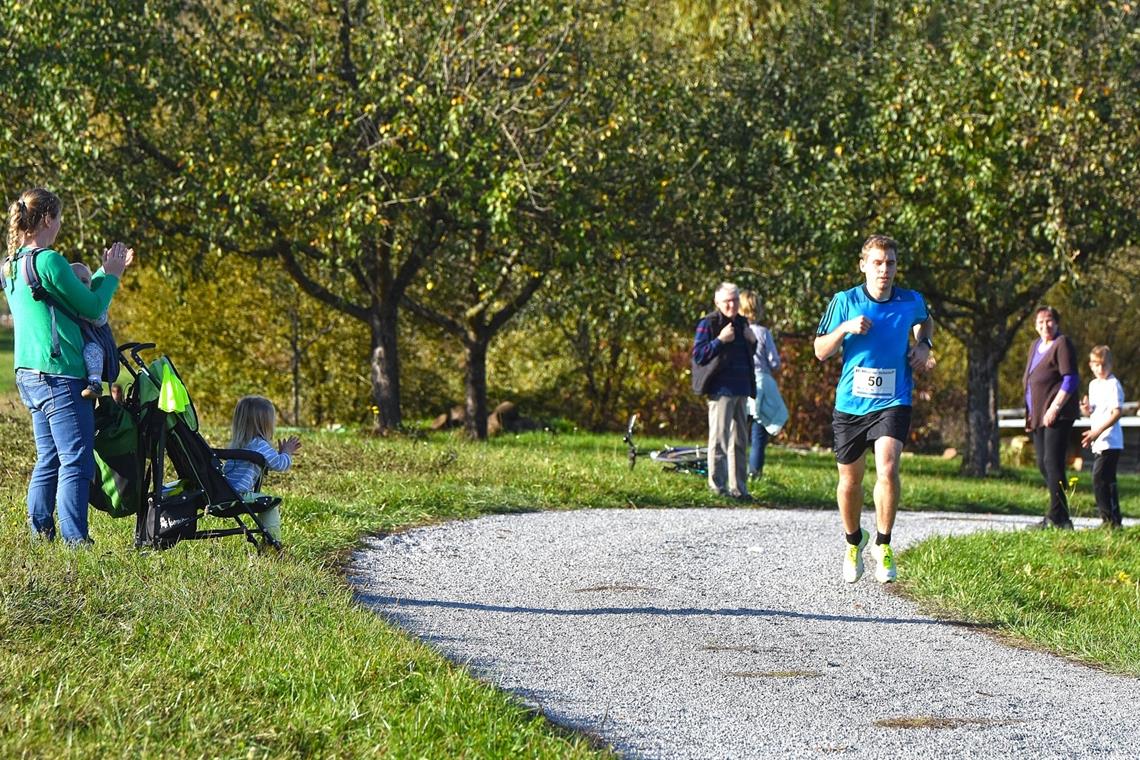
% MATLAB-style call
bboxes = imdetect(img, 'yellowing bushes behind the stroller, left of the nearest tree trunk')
[111,256,373,426]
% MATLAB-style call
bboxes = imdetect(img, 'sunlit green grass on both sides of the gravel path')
[0,394,1140,758]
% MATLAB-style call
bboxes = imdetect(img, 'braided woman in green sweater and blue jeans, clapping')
[3,188,133,545]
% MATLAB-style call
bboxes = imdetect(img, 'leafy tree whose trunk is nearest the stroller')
[4,0,620,426]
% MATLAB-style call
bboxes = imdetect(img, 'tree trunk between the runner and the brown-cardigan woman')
[962,333,1003,477]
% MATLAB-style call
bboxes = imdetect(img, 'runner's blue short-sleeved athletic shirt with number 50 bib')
[816,285,930,415]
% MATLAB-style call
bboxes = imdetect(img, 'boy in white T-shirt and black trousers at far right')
[1081,345,1124,530]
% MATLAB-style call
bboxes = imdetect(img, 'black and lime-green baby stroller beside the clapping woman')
[92,343,282,550]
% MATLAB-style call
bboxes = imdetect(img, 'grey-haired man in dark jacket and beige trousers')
[692,283,756,501]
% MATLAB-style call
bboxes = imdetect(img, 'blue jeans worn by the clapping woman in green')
[16,369,95,544]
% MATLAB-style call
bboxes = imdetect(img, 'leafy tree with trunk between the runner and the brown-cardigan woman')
[714,0,1140,474]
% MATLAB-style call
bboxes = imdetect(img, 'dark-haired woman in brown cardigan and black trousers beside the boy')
[1023,307,1081,529]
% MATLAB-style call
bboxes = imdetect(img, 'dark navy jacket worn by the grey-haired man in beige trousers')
[692,311,756,399]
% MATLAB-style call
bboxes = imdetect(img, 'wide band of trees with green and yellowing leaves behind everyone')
[0,0,1140,458]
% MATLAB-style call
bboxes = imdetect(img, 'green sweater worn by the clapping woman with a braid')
[5,248,119,378]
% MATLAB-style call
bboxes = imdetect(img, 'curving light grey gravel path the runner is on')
[350,508,1140,760]
